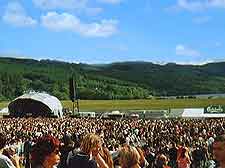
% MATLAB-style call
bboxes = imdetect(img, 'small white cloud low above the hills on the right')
[176,44,201,57]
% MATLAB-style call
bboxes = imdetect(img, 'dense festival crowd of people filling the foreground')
[0,117,225,168]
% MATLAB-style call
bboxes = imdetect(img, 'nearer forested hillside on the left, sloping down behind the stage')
[0,58,149,100]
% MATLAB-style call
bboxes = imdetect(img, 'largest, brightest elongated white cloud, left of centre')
[41,12,118,37]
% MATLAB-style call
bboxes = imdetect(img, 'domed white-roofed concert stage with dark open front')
[8,92,63,117]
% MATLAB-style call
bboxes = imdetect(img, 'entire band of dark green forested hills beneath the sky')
[0,57,225,100]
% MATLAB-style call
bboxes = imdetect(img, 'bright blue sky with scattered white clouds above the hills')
[0,0,225,64]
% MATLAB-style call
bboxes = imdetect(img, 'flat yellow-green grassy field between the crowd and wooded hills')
[0,98,225,111]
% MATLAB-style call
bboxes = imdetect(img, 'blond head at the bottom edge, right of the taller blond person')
[119,145,140,168]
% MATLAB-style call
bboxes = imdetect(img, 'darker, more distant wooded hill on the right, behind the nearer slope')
[92,62,225,95]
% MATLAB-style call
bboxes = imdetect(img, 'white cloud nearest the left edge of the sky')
[2,2,37,27]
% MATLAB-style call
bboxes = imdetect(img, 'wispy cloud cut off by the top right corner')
[171,0,225,12]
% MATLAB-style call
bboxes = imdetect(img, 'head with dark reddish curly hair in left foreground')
[31,135,60,166]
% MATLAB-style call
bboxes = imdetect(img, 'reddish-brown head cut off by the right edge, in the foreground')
[213,134,225,162]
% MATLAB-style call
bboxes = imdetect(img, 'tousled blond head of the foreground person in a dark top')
[80,133,101,155]
